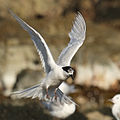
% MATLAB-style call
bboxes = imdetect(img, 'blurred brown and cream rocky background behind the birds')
[0,0,120,120]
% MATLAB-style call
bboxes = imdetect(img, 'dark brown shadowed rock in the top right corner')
[73,0,120,22]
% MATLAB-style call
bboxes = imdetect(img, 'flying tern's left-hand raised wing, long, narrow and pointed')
[9,10,55,73]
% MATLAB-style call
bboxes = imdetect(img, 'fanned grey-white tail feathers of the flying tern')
[11,84,76,105]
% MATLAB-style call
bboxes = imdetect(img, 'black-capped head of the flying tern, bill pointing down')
[62,66,75,80]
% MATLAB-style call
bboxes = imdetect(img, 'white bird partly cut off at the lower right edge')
[109,94,120,120]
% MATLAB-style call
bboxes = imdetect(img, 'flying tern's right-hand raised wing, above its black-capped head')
[57,13,86,66]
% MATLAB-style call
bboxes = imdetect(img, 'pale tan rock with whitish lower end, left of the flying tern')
[1,37,40,95]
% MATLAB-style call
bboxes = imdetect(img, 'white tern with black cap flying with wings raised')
[10,11,86,100]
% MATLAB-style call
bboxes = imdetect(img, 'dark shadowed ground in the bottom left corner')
[0,103,52,120]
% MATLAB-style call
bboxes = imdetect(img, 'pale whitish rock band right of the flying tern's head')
[75,63,120,89]
